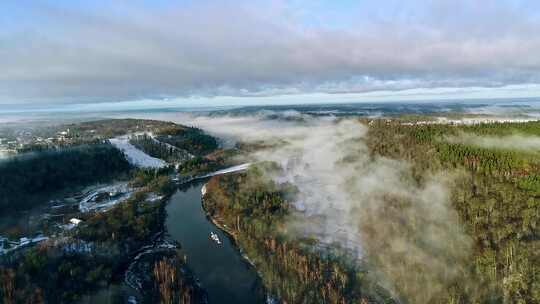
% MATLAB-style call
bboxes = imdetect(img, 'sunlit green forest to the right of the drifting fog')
[367,121,540,303]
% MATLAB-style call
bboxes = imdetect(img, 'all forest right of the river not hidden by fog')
[204,120,540,303]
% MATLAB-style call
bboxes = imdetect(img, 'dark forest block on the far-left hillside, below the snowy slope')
[0,143,131,212]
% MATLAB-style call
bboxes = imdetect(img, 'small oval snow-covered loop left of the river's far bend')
[79,183,133,212]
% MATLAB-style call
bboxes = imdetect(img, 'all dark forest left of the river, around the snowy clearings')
[0,119,216,303]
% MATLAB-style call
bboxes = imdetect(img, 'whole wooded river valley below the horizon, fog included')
[0,115,540,303]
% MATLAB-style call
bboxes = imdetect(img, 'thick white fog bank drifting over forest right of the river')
[148,111,474,303]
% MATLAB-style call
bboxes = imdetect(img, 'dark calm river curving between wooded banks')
[165,181,265,304]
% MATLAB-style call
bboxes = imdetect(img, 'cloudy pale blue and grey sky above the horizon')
[0,0,540,110]
